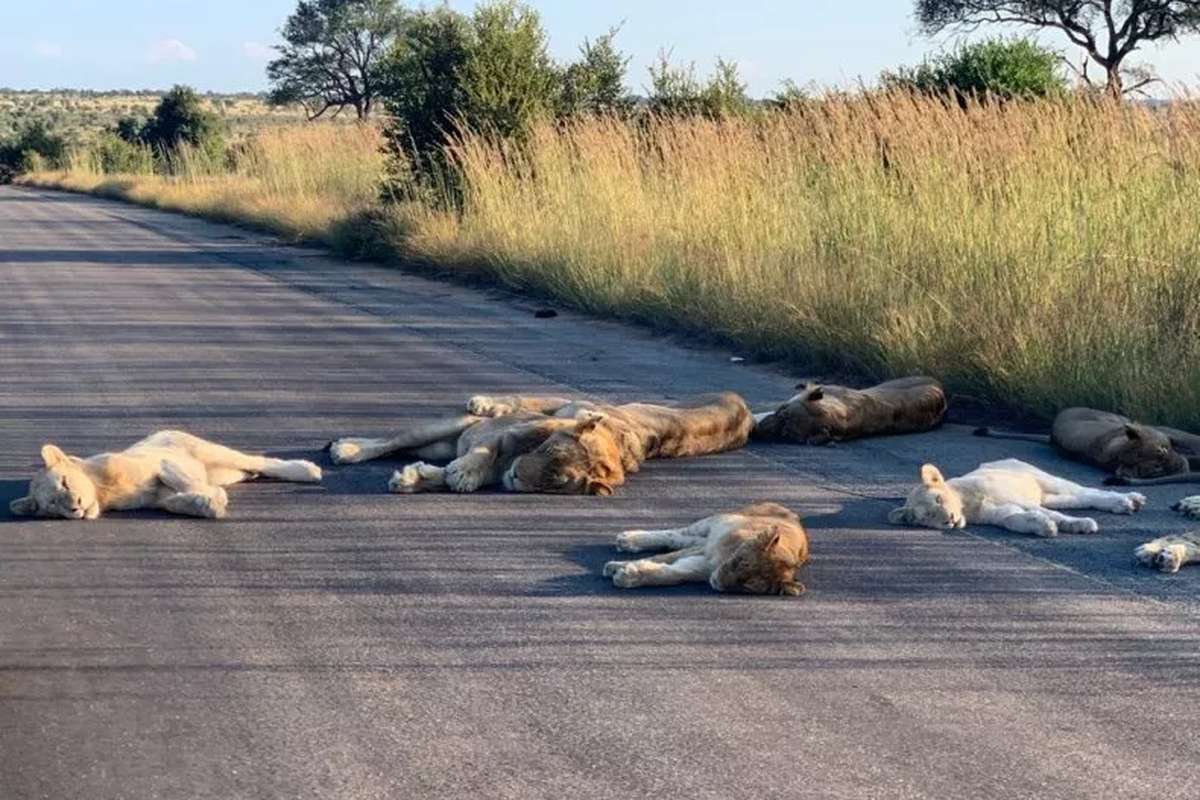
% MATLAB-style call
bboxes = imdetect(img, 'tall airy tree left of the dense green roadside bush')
[266,0,404,120]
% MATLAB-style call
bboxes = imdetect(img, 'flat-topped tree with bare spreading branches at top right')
[917,0,1200,98]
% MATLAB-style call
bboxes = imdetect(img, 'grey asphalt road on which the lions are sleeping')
[0,188,1200,800]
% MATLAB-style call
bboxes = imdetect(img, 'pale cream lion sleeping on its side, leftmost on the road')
[10,431,320,519]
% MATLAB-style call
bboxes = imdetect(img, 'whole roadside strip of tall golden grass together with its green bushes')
[14,4,1200,427]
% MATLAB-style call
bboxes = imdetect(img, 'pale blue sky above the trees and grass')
[0,0,1200,95]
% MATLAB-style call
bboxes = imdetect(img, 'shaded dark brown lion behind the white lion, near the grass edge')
[751,378,946,445]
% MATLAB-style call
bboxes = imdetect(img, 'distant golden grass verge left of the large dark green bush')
[25,125,384,241]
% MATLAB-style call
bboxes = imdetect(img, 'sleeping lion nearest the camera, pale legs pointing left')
[604,503,809,595]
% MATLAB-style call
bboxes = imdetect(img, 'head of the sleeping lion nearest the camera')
[708,523,808,595]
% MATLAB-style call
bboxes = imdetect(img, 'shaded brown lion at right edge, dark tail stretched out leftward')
[976,408,1200,486]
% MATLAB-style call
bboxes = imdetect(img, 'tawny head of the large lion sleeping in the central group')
[504,411,641,497]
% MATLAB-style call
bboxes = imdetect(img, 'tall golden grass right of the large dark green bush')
[410,96,1200,425]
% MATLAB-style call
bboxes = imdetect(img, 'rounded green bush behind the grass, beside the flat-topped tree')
[882,40,1067,101]
